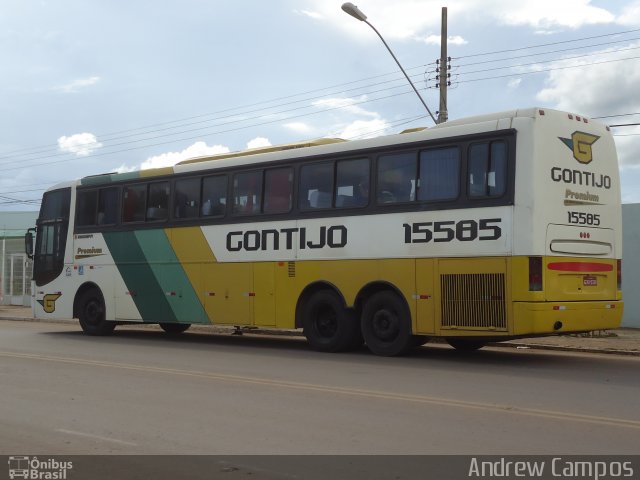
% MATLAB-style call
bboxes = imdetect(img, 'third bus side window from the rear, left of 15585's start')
[376,152,418,204]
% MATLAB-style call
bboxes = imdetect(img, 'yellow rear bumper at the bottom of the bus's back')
[513,301,624,336]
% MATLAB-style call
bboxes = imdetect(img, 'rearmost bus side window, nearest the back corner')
[467,141,507,198]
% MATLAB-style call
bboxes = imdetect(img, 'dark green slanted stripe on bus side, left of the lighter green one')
[103,230,177,322]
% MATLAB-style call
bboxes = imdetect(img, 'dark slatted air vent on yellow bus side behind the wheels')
[440,273,507,330]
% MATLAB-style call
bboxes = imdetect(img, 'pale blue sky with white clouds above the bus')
[0,0,640,211]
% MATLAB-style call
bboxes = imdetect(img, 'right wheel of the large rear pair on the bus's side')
[361,291,416,357]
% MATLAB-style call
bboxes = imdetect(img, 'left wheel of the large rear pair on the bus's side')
[302,290,360,352]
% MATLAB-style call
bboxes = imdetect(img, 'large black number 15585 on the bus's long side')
[403,218,502,243]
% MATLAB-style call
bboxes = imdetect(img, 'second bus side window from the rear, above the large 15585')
[418,147,460,201]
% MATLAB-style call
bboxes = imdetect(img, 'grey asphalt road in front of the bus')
[0,321,640,455]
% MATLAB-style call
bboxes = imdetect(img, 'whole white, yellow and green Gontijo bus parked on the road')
[27,108,623,355]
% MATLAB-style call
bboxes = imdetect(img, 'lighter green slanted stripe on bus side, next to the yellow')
[135,230,208,323]
